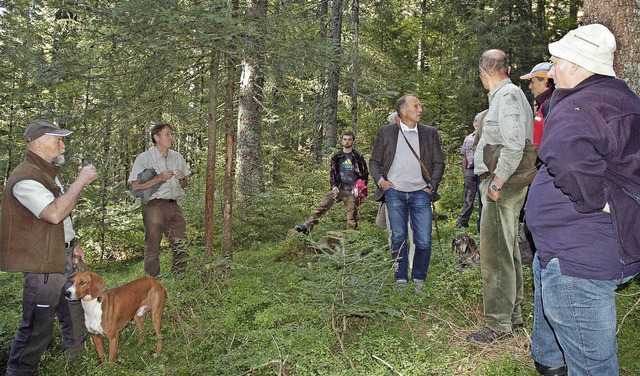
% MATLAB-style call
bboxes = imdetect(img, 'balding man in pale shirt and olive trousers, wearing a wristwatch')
[467,50,536,343]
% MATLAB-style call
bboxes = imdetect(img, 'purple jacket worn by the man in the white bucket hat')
[526,75,640,280]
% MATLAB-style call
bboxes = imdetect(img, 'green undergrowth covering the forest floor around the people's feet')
[0,203,640,375]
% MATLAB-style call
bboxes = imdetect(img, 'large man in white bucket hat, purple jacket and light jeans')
[527,24,640,375]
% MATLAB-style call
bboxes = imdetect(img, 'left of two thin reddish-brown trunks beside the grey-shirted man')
[209,52,220,256]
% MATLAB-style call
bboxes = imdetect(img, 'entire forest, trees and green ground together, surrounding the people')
[0,0,640,376]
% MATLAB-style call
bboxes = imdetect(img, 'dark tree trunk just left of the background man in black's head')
[324,0,343,154]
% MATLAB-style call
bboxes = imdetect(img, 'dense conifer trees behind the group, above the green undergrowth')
[0,0,640,258]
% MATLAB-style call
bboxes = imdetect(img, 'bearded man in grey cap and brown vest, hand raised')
[0,120,97,375]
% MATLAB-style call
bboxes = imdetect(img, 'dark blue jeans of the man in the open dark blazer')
[384,188,432,280]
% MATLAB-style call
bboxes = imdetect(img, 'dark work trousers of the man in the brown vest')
[7,247,86,375]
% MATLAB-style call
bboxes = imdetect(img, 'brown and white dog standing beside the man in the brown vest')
[66,271,167,362]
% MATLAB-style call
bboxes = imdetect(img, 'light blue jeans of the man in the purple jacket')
[531,254,632,376]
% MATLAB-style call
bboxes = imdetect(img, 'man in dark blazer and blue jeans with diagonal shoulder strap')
[369,95,444,293]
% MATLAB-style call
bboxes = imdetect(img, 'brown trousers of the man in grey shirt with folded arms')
[142,199,187,277]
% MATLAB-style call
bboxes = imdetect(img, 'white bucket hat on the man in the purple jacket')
[549,24,616,77]
